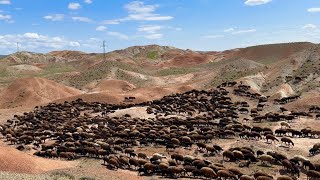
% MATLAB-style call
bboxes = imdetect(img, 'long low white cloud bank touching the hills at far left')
[0,32,81,53]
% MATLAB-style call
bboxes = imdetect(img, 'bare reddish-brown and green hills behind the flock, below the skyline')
[0,42,320,108]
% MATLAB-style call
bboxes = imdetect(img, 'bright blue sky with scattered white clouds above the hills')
[0,0,320,54]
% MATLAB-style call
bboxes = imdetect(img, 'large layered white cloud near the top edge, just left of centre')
[102,1,173,24]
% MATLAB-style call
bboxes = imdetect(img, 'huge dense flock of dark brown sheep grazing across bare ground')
[0,82,320,180]
